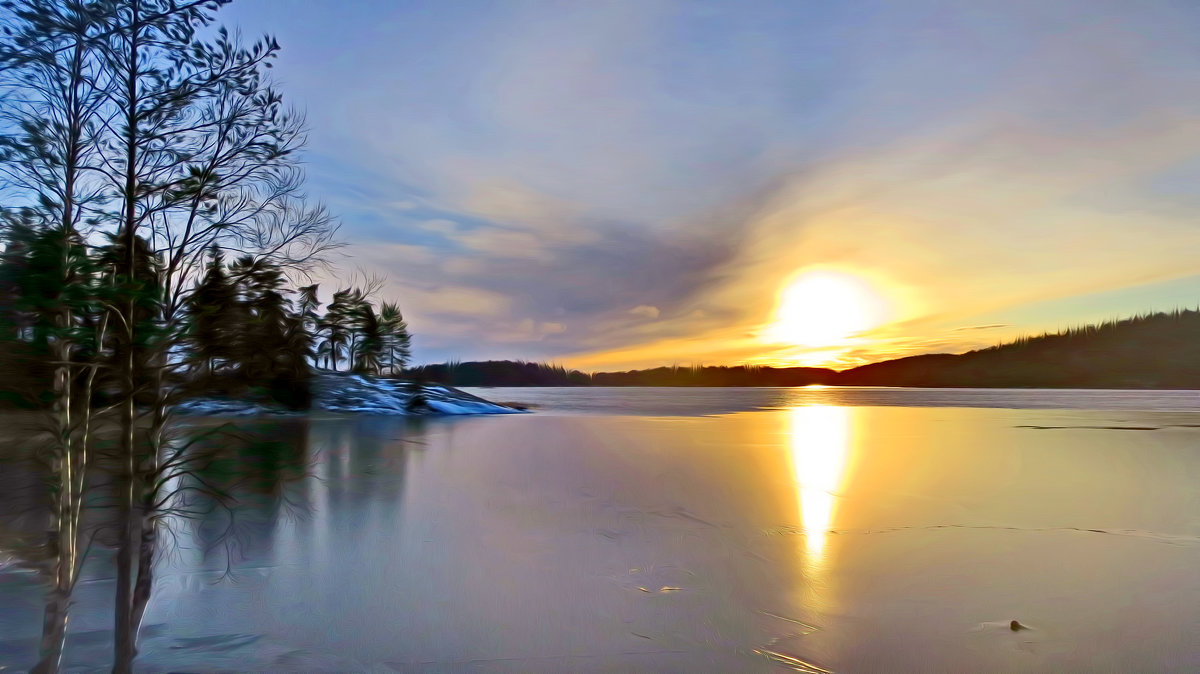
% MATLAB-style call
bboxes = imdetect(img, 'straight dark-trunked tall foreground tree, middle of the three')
[103,0,210,673]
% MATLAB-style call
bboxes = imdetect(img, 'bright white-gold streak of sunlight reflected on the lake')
[790,405,851,565]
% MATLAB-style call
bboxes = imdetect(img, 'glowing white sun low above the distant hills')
[766,271,883,348]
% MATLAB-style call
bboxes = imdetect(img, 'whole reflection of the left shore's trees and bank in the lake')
[0,417,426,666]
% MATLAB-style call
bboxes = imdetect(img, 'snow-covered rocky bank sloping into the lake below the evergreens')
[175,372,526,416]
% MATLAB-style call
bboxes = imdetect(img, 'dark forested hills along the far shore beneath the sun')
[409,311,1200,389]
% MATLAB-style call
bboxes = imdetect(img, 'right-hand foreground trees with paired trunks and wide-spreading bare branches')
[91,0,334,670]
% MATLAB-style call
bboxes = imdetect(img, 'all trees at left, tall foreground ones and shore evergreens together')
[0,0,408,672]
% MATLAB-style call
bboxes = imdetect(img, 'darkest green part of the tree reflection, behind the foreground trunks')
[0,420,310,672]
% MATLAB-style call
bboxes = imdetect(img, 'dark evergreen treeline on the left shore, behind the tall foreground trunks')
[0,233,410,409]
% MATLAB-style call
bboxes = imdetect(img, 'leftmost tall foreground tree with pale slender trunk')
[0,0,109,672]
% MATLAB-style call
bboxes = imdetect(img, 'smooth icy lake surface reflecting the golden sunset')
[0,389,1200,672]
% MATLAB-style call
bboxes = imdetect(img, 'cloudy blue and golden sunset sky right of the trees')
[220,0,1200,371]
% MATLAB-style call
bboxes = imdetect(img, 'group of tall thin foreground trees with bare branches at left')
[0,0,336,672]
